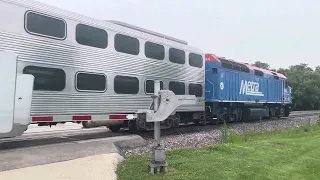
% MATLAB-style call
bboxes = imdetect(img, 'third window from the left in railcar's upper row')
[114,34,140,55]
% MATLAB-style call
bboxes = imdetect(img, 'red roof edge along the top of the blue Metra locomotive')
[206,54,287,79]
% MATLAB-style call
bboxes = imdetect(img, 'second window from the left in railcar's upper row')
[76,24,108,49]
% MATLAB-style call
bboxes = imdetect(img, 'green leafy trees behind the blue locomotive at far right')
[252,61,320,111]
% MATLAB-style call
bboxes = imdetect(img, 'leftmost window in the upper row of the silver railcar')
[25,11,67,39]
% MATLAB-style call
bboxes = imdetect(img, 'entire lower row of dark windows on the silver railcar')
[23,66,202,97]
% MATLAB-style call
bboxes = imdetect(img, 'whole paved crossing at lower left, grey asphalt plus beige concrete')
[0,131,146,180]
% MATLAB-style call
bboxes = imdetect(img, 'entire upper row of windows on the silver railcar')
[25,11,203,68]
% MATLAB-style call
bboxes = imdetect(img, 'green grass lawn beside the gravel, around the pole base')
[117,120,320,180]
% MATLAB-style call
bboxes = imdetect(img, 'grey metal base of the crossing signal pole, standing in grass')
[149,146,168,174]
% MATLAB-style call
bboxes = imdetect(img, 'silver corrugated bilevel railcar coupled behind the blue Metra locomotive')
[0,0,205,131]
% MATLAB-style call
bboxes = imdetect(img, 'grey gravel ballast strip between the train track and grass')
[121,116,319,156]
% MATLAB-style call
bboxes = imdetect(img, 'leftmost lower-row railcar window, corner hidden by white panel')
[23,66,66,91]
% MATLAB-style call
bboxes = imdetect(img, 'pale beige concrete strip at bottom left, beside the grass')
[0,153,123,180]
